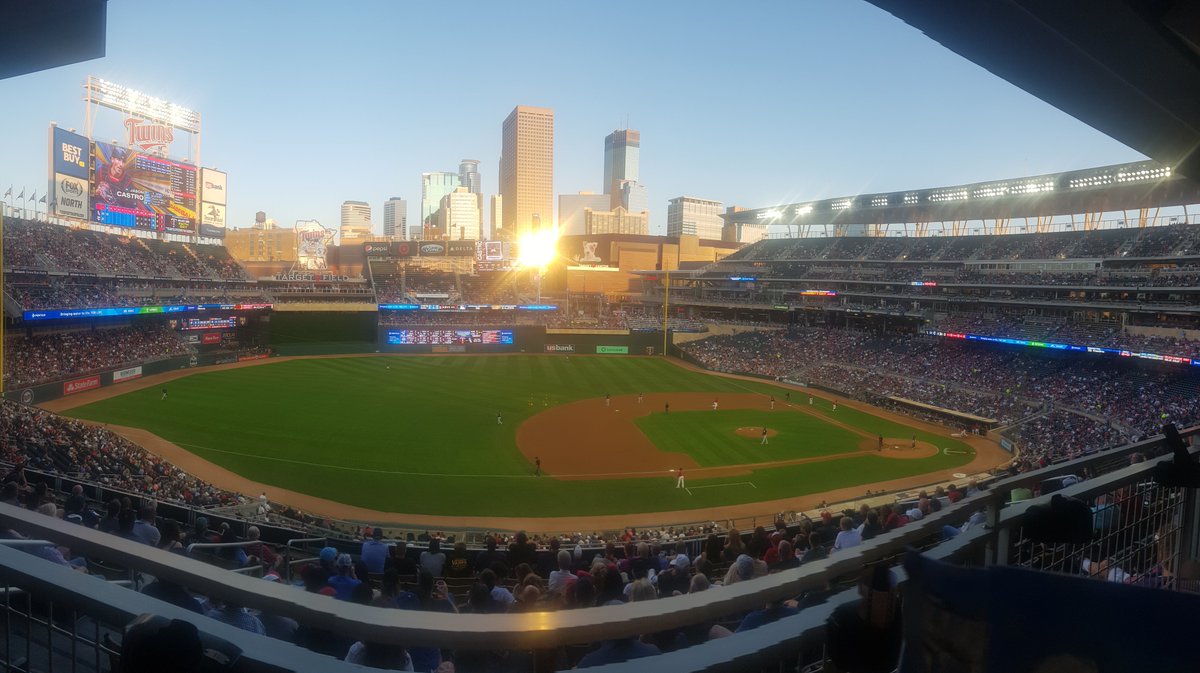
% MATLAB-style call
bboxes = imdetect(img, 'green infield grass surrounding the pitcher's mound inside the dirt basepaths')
[634,405,863,467]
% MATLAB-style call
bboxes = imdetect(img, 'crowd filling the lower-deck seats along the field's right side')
[683,328,1200,456]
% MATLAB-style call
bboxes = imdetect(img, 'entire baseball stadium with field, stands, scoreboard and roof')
[0,0,1200,673]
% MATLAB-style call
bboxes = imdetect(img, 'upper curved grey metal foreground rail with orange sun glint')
[0,428,1196,649]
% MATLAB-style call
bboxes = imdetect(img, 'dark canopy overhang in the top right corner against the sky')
[869,0,1200,180]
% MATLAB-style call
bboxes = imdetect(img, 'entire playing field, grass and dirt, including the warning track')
[48,355,1008,524]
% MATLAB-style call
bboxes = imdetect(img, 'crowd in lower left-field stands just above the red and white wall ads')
[4,325,191,390]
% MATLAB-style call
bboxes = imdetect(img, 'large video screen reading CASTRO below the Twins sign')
[91,143,197,234]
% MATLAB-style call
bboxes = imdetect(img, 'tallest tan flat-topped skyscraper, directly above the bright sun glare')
[500,106,554,238]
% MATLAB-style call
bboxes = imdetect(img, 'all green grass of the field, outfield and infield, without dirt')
[68,355,972,516]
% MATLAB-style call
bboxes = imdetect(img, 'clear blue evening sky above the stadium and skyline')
[0,0,1145,233]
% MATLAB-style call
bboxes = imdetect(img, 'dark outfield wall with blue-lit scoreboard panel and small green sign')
[377,325,662,355]
